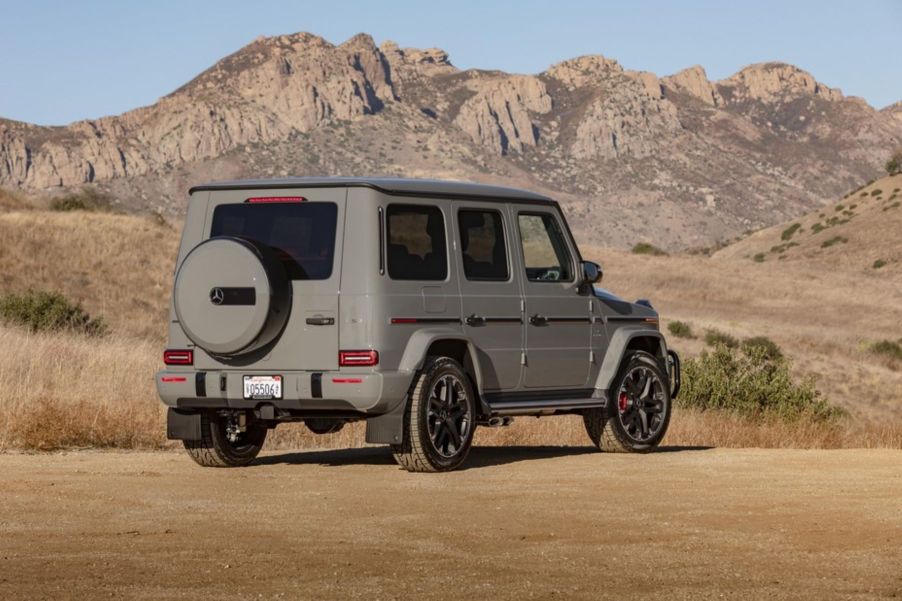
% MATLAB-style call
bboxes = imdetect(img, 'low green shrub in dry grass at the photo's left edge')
[0,290,108,336]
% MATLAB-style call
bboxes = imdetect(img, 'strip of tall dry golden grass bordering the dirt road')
[0,327,902,450]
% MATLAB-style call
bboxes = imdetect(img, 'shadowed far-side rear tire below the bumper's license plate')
[182,412,266,467]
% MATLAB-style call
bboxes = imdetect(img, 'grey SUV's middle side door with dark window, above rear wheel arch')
[454,202,524,392]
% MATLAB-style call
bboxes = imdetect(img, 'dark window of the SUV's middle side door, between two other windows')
[457,209,509,282]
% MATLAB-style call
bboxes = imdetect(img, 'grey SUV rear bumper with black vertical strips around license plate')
[154,370,413,415]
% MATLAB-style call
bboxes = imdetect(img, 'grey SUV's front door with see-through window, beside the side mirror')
[513,205,591,389]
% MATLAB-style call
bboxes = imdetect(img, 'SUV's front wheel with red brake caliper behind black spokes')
[583,351,672,453]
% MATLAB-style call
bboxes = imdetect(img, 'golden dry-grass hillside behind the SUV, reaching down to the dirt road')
[0,190,902,448]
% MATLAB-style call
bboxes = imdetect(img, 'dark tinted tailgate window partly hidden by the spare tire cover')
[210,202,338,280]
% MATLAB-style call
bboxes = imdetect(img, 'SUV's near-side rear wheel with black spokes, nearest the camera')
[392,357,476,472]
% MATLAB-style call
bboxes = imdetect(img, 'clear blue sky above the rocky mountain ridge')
[0,0,902,124]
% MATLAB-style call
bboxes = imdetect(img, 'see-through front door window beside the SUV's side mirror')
[518,213,573,282]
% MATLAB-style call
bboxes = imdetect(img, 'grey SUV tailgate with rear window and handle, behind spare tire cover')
[195,188,347,371]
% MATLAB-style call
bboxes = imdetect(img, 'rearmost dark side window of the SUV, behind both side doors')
[386,205,448,280]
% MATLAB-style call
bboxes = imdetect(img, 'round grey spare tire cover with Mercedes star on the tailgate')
[173,236,291,356]
